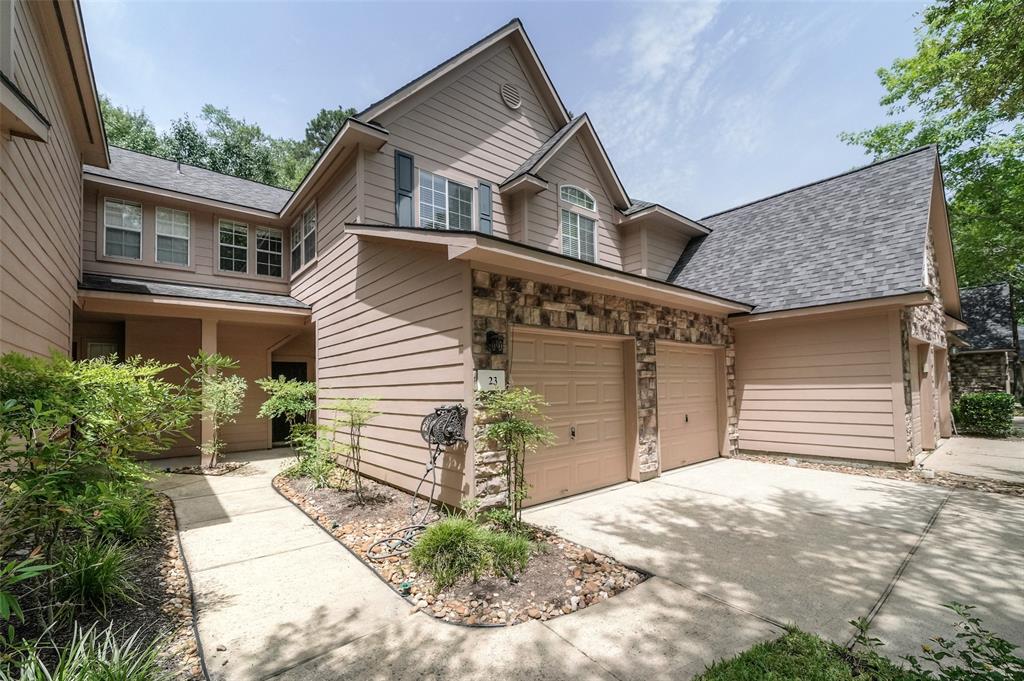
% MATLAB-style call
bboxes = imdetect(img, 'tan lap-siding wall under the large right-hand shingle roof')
[736,314,904,461]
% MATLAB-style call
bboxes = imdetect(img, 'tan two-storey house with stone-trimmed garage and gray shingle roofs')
[2,10,962,503]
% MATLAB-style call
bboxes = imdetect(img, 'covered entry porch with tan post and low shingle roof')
[72,274,316,459]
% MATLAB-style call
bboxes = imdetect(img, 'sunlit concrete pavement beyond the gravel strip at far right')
[922,437,1024,484]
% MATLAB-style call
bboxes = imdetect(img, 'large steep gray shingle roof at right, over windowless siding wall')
[669,146,936,313]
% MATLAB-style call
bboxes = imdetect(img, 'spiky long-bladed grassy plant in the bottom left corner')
[0,625,172,681]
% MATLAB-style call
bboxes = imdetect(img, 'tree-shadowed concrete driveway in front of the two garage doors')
[527,459,1024,656]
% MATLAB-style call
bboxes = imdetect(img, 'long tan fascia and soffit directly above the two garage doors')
[345,224,751,314]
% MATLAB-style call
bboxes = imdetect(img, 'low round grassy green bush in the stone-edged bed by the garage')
[410,517,531,589]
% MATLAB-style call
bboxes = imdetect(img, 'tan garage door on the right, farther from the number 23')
[657,341,719,470]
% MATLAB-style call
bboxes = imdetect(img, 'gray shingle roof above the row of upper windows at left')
[84,146,292,213]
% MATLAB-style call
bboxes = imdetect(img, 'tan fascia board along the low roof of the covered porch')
[78,289,312,324]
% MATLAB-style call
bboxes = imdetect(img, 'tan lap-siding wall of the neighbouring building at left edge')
[0,2,82,354]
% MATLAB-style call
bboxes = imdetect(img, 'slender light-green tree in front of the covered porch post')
[188,350,246,468]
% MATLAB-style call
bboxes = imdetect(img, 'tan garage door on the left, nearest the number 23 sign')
[511,329,627,505]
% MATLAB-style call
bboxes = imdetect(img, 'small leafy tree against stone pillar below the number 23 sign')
[477,388,555,521]
